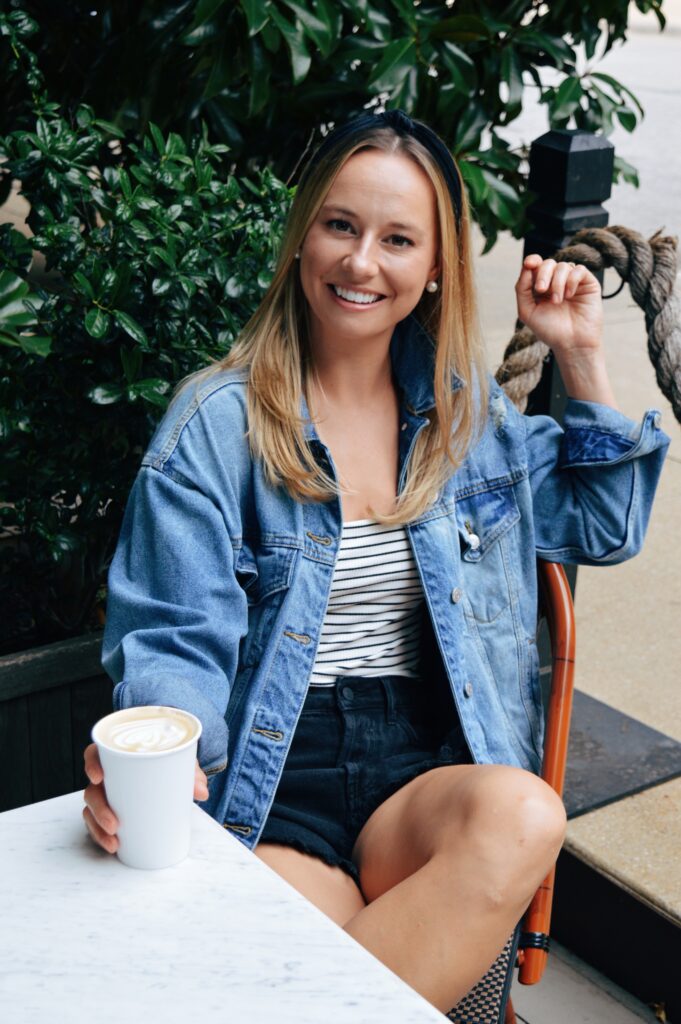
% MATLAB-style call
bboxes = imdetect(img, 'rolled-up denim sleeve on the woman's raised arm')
[524,398,670,565]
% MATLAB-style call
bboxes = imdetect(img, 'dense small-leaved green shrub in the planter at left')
[0,12,292,651]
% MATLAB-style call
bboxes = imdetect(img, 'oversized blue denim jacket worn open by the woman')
[102,317,669,849]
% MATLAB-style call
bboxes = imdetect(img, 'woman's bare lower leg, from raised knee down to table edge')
[344,768,565,1013]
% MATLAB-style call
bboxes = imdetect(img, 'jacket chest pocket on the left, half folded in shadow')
[236,544,296,668]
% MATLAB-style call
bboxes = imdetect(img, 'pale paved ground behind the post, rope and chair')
[477,6,681,1024]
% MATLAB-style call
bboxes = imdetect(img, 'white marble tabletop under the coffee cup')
[0,792,444,1024]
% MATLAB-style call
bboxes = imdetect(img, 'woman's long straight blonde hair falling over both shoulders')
[187,127,486,523]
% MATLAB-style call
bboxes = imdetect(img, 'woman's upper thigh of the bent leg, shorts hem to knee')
[351,764,565,902]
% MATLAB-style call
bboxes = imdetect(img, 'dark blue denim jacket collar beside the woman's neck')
[300,313,466,440]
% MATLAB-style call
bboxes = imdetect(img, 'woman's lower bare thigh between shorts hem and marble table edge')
[253,843,367,927]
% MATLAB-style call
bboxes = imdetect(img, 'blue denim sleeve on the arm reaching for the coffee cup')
[102,466,247,774]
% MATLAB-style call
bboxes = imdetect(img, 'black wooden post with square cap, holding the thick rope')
[523,128,614,688]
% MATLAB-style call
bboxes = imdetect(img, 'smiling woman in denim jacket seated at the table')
[84,112,668,1012]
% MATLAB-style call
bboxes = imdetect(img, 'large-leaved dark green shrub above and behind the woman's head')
[0,0,665,248]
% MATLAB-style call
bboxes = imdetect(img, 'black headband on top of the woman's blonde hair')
[301,111,462,229]
